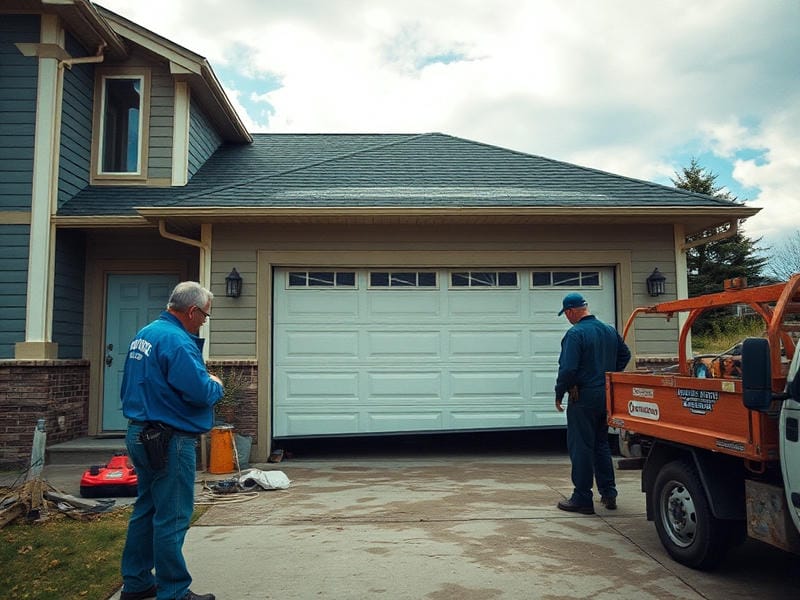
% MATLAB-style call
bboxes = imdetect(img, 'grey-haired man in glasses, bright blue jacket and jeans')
[120,281,223,600]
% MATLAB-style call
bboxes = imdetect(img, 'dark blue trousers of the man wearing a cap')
[567,388,617,506]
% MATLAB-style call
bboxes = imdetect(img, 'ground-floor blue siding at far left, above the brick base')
[0,225,30,358]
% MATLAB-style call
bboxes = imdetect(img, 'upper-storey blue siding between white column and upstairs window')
[58,35,94,208]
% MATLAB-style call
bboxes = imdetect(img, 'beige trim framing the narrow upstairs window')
[91,67,151,184]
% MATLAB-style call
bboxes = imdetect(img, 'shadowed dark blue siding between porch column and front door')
[53,229,86,358]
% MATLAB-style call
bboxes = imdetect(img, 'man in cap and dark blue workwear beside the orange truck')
[556,293,631,515]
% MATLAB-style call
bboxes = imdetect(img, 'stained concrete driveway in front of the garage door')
[170,450,800,600]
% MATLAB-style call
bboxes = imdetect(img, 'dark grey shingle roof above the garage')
[58,133,741,216]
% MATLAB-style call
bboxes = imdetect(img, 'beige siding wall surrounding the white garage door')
[210,224,677,358]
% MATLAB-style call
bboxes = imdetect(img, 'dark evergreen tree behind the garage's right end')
[672,158,768,333]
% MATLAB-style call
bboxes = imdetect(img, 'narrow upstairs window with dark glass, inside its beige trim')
[100,77,144,174]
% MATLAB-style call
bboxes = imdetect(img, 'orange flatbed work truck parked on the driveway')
[606,274,800,569]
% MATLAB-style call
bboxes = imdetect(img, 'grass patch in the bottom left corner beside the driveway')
[0,507,131,600]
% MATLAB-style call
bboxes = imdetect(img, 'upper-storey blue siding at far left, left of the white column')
[0,15,39,211]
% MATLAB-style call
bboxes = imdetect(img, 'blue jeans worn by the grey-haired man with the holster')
[122,423,197,599]
